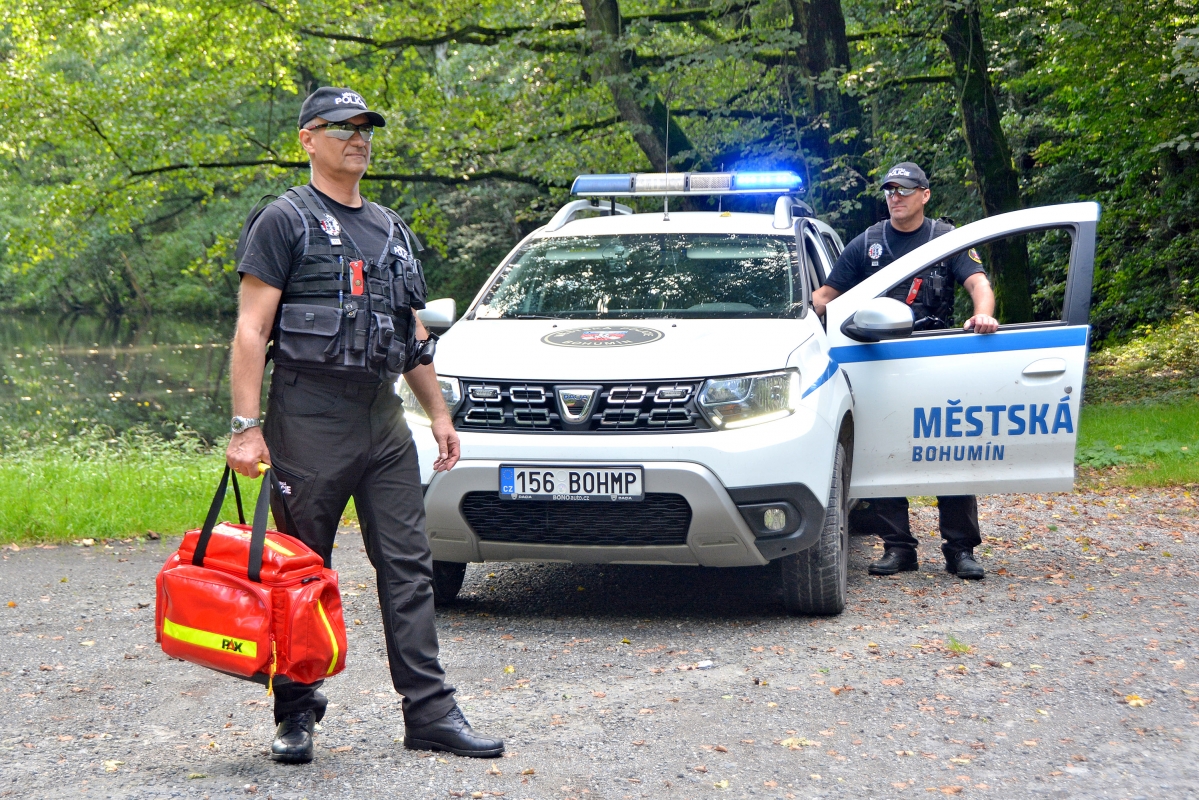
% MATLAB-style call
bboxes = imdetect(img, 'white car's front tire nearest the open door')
[778,443,849,615]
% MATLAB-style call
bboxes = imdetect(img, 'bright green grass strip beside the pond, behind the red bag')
[0,428,354,543]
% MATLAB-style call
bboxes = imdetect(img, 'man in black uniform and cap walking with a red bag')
[227,88,504,763]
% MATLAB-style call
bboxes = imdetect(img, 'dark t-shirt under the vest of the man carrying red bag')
[237,187,391,289]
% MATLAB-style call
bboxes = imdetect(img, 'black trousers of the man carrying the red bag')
[263,366,454,726]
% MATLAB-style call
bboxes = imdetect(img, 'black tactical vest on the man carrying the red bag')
[270,186,427,380]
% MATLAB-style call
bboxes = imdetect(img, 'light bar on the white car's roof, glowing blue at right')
[571,172,803,197]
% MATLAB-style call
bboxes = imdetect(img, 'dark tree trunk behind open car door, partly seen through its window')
[941,0,1032,323]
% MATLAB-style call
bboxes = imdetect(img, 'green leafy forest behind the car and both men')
[0,0,1199,341]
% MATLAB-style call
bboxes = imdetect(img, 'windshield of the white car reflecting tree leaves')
[476,234,802,319]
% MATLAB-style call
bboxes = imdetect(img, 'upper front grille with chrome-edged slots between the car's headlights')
[454,378,711,433]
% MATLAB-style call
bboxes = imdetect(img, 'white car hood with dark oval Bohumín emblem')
[435,314,819,380]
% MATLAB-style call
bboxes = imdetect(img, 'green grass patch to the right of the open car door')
[1076,399,1199,486]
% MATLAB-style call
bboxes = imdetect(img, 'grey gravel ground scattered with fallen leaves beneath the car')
[0,489,1199,800]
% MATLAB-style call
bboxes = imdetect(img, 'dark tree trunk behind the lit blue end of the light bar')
[789,0,885,237]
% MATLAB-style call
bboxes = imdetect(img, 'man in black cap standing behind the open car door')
[812,162,999,579]
